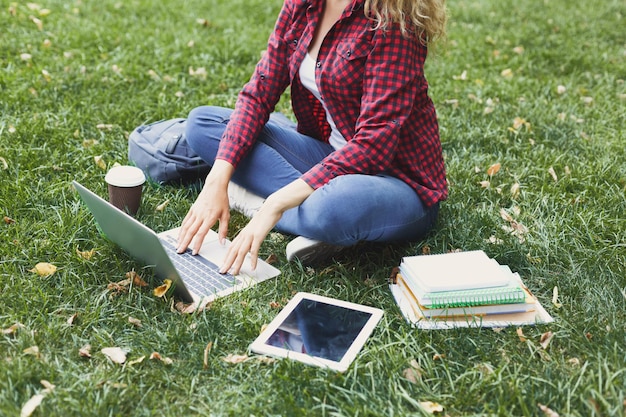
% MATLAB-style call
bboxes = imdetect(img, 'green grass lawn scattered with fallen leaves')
[0,0,626,416]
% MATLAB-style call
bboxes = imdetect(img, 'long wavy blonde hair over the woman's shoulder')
[365,0,448,45]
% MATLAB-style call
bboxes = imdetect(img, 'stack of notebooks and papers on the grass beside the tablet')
[390,251,552,328]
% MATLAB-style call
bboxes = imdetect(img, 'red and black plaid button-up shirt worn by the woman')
[217,0,447,206]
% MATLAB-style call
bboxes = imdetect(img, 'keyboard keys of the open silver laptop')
[161,236,237,296]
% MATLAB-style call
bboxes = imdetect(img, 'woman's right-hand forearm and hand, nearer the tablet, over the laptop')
[220,179,313,275]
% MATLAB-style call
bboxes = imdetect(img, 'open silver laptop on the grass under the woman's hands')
[72,181,280,308]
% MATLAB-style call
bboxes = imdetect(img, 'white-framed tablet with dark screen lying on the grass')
[250,292,383,372]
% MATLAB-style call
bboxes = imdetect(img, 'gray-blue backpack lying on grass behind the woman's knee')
[128,119,211,184]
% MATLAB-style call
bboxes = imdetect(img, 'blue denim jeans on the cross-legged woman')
[186,106,439,246]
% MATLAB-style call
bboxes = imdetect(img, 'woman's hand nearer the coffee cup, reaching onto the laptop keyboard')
[176,160,234,255]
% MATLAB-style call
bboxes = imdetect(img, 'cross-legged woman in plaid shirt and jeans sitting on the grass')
[178,0,447,274]
